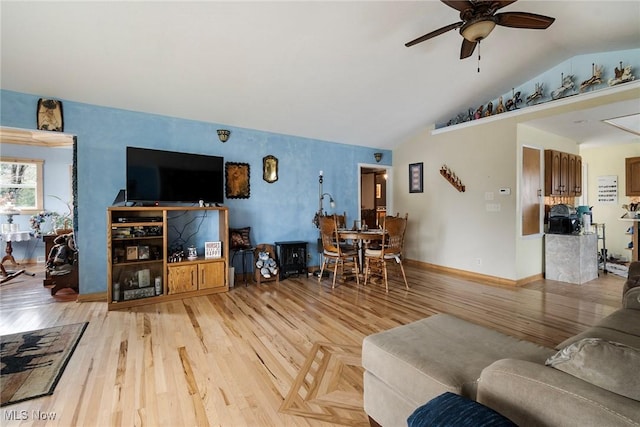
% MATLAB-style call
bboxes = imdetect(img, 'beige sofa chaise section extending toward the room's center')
[362,314,554,408]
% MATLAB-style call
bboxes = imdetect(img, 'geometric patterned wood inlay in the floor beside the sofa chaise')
[280,342,369,426]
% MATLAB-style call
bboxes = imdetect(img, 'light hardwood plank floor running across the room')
[0,266,624,426]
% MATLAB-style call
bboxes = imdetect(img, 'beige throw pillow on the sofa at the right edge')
[546,338,640,400]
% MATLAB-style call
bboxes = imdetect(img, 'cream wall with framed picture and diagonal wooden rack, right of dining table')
[393,122,517,278]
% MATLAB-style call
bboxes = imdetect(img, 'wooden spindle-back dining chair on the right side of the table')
[364,215,409,292]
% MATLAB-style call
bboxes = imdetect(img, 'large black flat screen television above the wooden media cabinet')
[126,147,224,204]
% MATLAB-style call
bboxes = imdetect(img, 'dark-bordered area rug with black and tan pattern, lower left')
[0,322,88,406]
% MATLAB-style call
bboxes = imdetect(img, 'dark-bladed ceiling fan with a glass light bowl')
[405,0,555,59]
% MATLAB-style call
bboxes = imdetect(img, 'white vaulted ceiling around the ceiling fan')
[0,0,640,148]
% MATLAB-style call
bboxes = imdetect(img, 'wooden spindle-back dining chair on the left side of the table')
[318,215,360,288]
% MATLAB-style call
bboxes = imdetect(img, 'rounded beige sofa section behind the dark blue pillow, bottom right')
[476,359,640,427]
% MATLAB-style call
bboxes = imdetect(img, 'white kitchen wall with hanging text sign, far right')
[580,143,640,259]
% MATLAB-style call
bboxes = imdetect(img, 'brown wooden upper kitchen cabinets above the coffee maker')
[544,150,582,197]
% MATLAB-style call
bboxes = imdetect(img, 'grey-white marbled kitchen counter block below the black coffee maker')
[544,233,598,285]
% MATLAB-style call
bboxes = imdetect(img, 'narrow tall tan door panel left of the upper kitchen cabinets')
[521,147,542,236]
